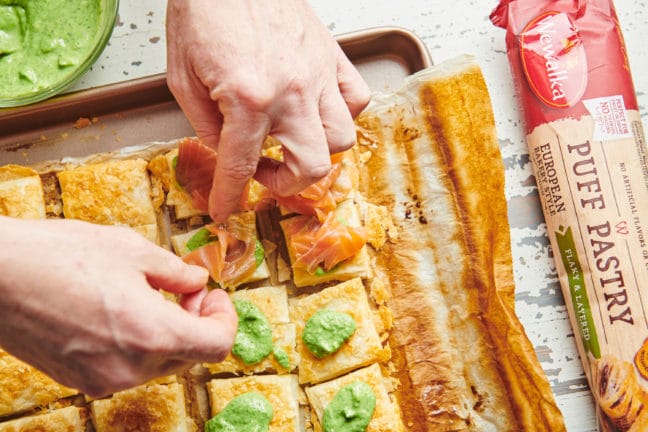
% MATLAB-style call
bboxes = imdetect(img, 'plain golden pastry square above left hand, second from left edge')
[57,159,158,243]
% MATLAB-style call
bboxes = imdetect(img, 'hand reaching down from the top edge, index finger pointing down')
[167,0,370,222]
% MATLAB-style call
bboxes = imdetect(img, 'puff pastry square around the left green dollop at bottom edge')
[207,375,302,432]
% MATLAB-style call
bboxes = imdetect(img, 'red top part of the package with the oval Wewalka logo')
[490,0,637,132]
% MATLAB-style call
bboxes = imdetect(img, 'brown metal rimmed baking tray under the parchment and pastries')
[0,27,432,165]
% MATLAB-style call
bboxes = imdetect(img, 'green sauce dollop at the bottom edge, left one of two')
[205,392,274,432]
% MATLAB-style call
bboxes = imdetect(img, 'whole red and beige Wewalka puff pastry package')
[490,0,648,432]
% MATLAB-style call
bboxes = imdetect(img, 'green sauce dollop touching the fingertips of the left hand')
[232,300,272,365]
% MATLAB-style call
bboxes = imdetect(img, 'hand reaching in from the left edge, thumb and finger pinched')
[0,217,237,396]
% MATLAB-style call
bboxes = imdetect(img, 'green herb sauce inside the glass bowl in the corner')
[0,0,101,98]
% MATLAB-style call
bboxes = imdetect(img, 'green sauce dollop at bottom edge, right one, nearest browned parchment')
[322,381,376,432]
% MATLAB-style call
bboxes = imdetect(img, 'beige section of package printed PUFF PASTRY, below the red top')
[527,112,648,374]
